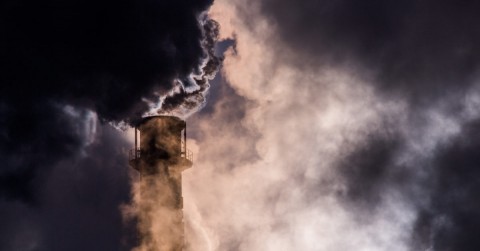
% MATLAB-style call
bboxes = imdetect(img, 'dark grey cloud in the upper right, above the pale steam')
[256,0,480,98]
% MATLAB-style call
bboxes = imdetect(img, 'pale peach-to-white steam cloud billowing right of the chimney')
[178,0,480,251]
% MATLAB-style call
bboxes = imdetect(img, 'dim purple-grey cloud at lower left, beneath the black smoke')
[0,126,135,251]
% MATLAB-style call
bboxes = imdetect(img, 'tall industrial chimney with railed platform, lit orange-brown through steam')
[129,116,192,251]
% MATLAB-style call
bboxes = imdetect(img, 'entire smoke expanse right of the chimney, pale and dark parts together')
[179,0,480,251]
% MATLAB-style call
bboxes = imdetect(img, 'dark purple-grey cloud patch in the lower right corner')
[414,120,480,250]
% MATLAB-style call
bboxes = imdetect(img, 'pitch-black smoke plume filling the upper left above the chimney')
[0,0,218,200]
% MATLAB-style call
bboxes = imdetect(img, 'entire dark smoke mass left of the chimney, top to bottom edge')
[0,0,220,250]
